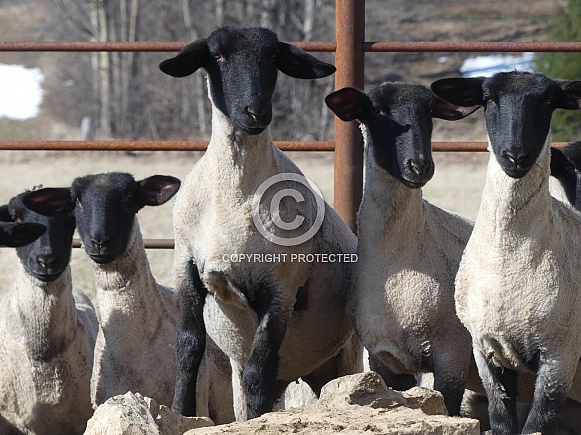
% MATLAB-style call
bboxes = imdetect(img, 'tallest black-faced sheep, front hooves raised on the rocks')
[160,28,362,420]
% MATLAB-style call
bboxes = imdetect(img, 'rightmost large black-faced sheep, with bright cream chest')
[432,72,581,433]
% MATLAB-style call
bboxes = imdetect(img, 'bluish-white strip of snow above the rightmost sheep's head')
[460,53,534,77]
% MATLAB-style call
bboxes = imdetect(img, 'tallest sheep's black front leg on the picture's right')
[242,289,290,419]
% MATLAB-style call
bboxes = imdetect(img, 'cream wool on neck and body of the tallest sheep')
[173,100,362,419]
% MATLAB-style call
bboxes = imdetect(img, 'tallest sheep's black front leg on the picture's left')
[172,260,208,417]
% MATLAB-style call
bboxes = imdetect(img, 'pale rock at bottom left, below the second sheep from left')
[85,392,214,435]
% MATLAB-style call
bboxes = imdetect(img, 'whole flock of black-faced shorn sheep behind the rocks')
[0,27,581,435]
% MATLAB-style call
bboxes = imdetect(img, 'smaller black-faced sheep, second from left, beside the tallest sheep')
[70,172,234,424]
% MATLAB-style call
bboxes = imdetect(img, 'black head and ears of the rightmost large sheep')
[432,71,581,178]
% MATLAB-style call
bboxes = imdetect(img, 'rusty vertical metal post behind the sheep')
[334,0,365,232]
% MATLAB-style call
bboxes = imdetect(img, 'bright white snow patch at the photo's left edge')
[0,64,44,121]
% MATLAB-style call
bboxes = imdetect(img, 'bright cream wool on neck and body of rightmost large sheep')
[456,135,581,401]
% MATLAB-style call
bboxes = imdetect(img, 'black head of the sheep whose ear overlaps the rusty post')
[325,82,478,189]
